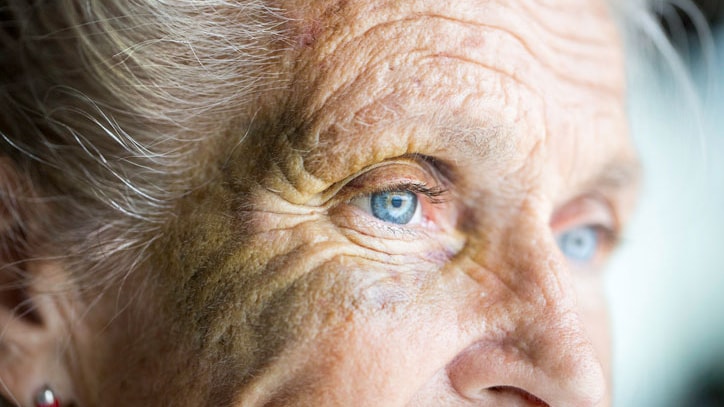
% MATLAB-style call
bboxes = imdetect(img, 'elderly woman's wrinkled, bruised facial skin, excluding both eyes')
[76,0,635,407]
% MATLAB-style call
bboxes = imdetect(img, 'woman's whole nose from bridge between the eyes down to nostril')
[447,225,607,407]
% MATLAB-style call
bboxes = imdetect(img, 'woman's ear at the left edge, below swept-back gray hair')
[0,157,74,406]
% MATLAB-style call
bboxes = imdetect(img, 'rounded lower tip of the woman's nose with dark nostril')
[448,310,606,407]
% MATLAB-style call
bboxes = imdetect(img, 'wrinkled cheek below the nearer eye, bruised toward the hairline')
[219,201,470,405]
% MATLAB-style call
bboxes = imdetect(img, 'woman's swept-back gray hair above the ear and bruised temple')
[0,0,284,283]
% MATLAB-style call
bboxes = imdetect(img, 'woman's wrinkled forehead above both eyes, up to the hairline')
[272,0,630,199]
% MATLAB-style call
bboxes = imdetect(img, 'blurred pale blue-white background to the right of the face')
[607,0,724,407]
